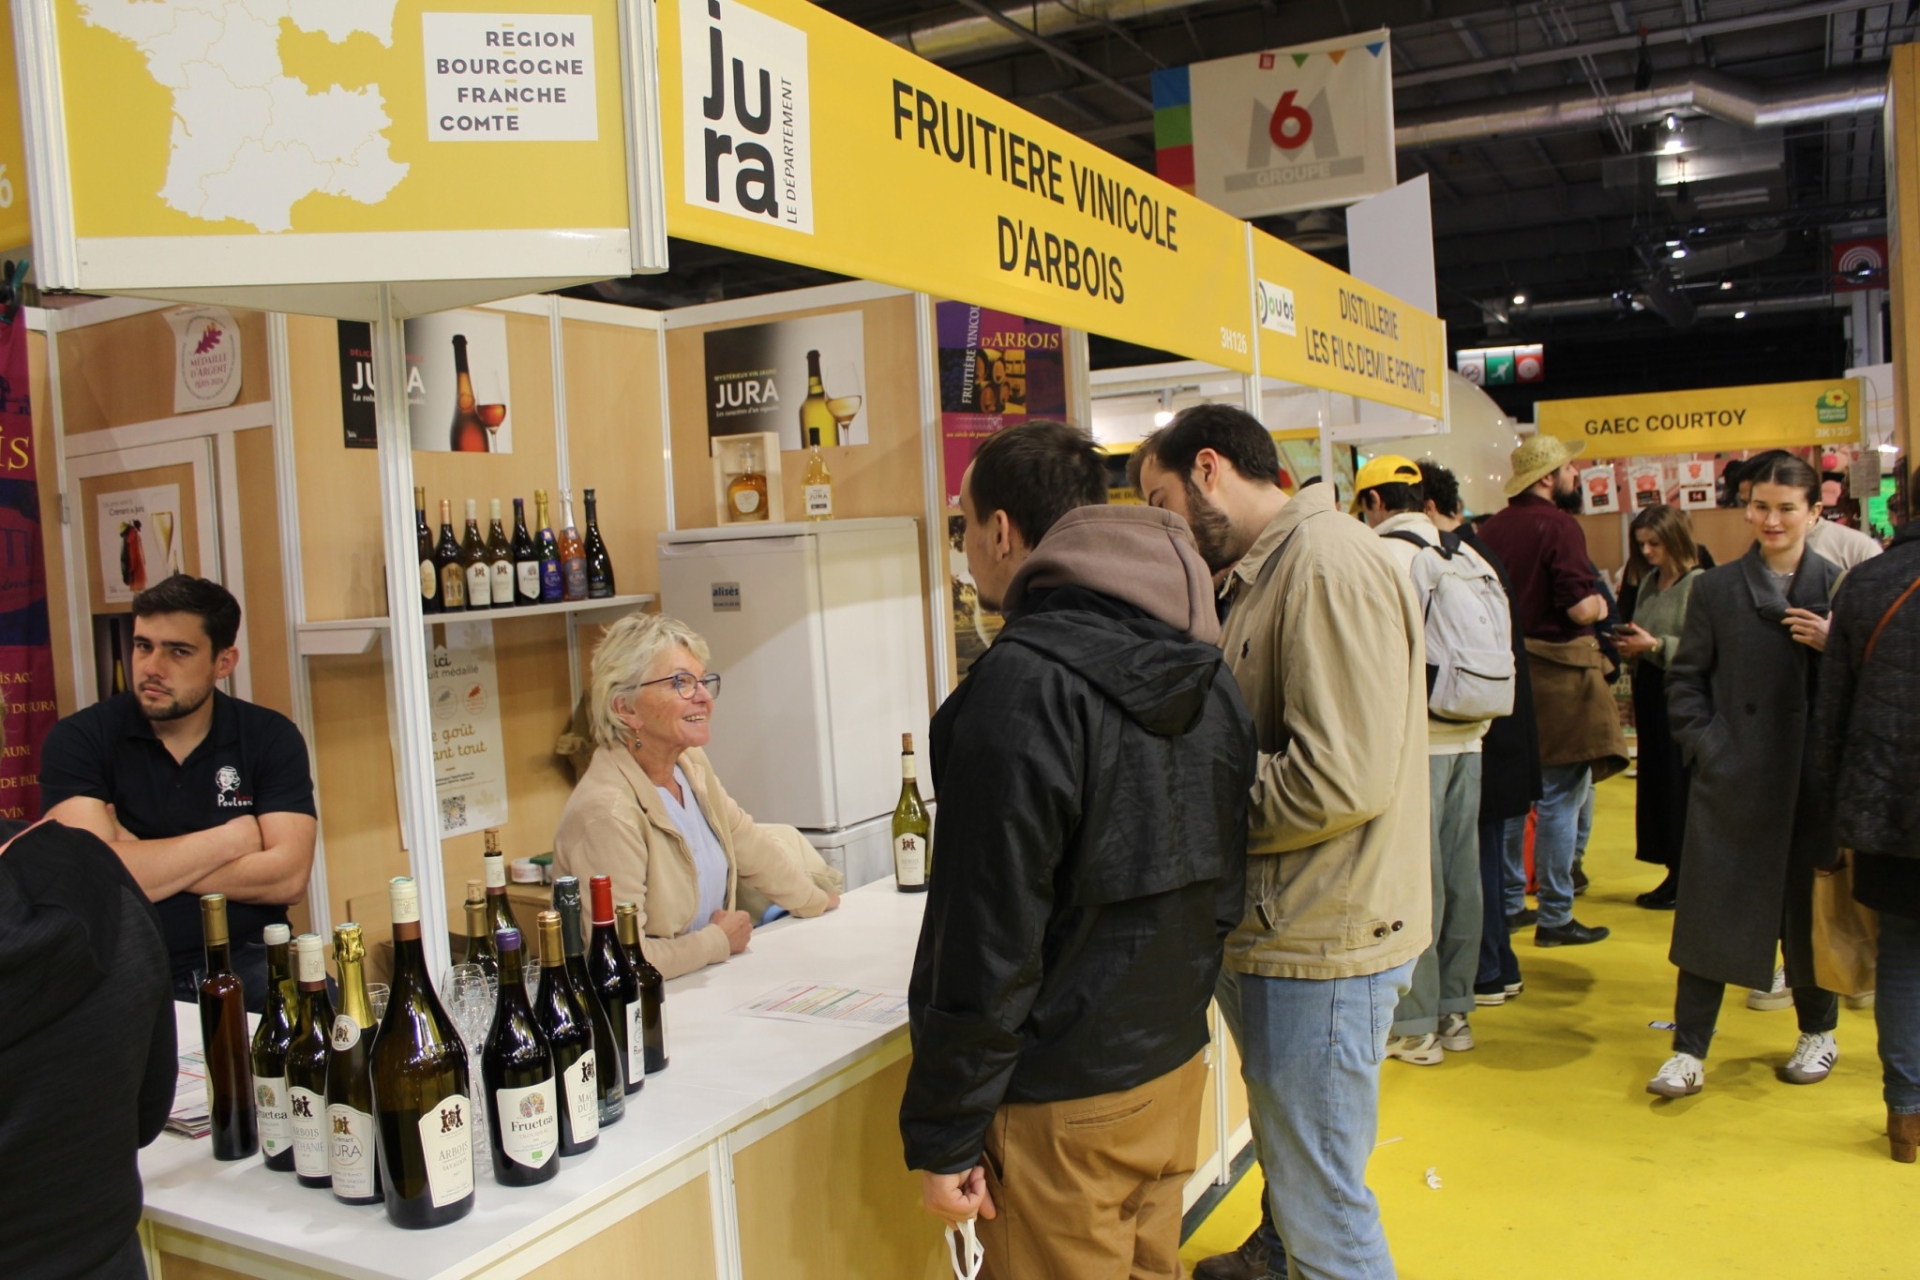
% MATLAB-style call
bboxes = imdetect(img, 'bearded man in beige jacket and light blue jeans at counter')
[1133,405,1432,1280]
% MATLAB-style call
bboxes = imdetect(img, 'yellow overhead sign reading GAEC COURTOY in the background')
[1534,378,1860,459]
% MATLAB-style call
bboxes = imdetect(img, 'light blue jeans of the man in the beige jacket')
[1217,960,1413,1280]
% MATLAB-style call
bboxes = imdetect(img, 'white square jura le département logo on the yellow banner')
[680,0,814,234]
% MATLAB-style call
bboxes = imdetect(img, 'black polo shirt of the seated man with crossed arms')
[40,691,313,977]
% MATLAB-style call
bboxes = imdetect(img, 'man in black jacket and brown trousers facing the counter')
[900,422,1256,1280]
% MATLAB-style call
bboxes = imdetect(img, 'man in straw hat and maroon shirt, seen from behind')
[1480,436,1626,946]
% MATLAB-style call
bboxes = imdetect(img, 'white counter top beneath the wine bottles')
[140,879,925,1280]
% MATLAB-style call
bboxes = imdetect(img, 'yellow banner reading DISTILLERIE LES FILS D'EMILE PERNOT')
[1254,230,1446,418]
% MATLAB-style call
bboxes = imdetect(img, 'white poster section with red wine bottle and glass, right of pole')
[407,311,513,453]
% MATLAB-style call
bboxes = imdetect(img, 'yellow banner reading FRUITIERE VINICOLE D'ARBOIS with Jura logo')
[659,0,1252,372]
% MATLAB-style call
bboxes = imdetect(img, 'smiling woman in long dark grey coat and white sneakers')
[1647,455,1841,1098]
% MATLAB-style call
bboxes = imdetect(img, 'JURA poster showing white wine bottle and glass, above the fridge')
[707,311,866,453]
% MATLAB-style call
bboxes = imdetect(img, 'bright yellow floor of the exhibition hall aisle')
[1181,779,1920,1280]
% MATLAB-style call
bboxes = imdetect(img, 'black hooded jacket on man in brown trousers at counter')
[900,585,1256,1173]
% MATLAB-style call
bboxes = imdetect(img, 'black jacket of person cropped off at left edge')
[0,821,179,1280]
